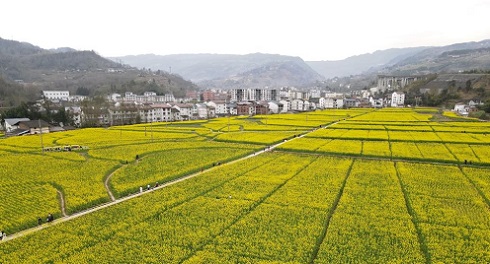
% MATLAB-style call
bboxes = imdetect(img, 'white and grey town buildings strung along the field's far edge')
[2,78,413,132]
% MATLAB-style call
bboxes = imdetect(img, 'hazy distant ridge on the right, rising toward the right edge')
[306,40,490,78]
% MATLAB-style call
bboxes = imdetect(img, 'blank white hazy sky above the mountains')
[0,0,490,60]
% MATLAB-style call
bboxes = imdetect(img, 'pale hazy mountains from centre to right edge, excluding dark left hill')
[110,40,490,88]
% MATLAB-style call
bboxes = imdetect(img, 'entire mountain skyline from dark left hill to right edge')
[0,35,490,105]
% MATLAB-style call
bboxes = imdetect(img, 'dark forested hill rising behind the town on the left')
[0,38,197,107]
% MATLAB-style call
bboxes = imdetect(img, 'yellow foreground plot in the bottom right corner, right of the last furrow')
[397,163,490,263]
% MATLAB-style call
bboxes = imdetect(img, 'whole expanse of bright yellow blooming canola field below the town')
[0,109,490,263]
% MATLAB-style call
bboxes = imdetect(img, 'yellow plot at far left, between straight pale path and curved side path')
[0,153,118,232]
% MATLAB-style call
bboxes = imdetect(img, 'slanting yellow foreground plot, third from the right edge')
[188,157,352,263]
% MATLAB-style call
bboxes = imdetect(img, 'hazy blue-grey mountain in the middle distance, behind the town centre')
[111,53,324,88]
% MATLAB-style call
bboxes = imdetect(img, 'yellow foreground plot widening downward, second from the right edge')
[315,160,425,263]
